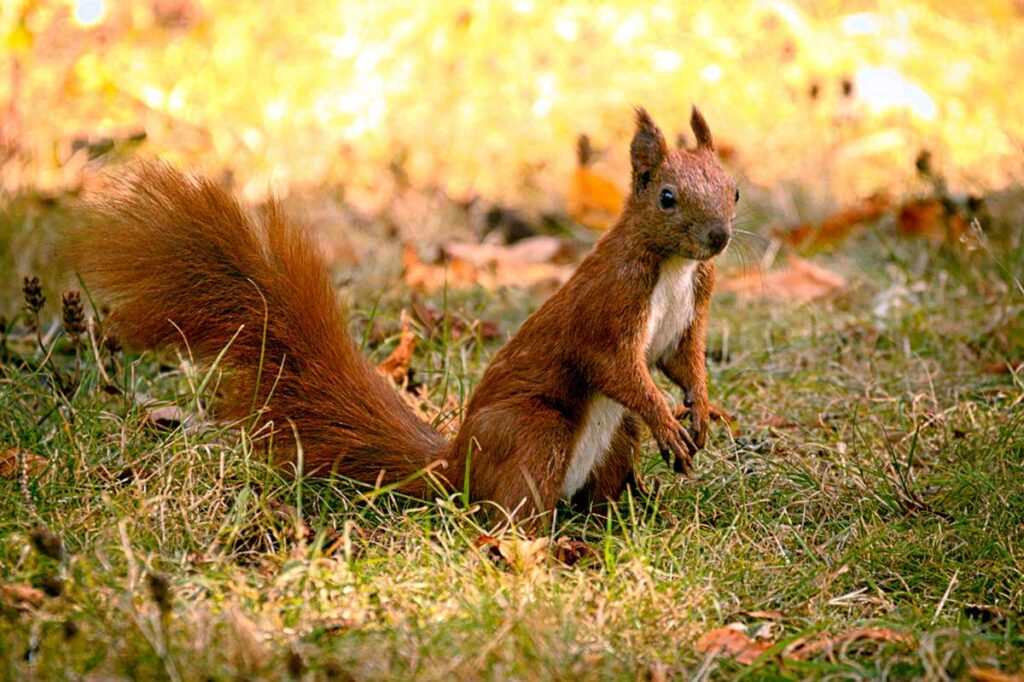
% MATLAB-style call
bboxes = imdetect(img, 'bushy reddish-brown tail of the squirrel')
[68,162,445,494]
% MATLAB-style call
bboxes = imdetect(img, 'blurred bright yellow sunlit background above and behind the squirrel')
[0,0,1024,294]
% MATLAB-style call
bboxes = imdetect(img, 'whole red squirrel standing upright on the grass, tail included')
[68,108,739,519]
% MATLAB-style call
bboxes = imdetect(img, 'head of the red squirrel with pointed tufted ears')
[627,106,739,260]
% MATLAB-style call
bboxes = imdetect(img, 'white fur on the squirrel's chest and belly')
[562,258,697,498]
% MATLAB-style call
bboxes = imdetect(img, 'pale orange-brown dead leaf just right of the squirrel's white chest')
[719,256,846,302]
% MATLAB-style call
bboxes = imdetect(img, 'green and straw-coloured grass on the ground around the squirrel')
[0,184,1024,680]
